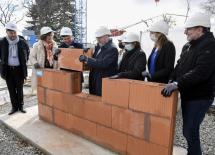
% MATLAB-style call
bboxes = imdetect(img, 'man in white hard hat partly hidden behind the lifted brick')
[59,27,83,49]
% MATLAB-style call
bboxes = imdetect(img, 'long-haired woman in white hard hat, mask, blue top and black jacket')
[142,21,176,83]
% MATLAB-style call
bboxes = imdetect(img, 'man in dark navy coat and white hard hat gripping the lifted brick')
[80,27,118,96]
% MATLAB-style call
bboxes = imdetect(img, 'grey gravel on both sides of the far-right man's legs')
[174,108,215,155]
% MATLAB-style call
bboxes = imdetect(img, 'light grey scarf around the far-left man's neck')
[6,36,19,58]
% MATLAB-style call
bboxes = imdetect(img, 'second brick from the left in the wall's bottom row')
[54,109,71,130]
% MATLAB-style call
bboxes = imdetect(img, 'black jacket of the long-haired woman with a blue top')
[148,41,175,83]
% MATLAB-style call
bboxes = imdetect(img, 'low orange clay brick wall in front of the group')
[38,71,177,155]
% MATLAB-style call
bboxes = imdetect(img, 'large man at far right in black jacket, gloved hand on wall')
[162,13,215,155]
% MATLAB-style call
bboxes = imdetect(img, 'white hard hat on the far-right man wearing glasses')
[185,12,211,28]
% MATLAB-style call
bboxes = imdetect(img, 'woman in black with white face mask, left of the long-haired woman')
[111,33,146,80]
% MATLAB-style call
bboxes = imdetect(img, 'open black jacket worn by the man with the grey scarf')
[0,38,30,79]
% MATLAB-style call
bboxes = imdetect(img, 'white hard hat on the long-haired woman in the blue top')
[149,20,169,35]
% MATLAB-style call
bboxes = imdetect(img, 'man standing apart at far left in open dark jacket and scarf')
[0,22,29,115]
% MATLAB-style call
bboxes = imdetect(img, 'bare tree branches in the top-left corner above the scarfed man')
[0,0,24,26]
